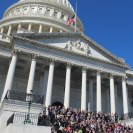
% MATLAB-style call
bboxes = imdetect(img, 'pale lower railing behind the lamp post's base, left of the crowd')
[7,112,38,126]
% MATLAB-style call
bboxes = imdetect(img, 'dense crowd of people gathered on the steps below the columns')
[38,106,133,133]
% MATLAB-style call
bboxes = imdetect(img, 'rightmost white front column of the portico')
[122,77,128,114]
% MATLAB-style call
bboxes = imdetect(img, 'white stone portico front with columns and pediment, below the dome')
[1,33,132,114]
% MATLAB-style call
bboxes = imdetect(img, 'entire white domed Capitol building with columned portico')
[0,0,133,131]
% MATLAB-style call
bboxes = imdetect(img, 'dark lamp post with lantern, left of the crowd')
[24,92,34,124]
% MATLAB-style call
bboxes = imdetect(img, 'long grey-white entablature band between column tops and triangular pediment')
[12,36,127,76]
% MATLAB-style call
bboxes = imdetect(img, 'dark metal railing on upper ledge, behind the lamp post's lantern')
[5,90,44,104]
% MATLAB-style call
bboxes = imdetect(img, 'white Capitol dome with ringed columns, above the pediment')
[0,0,83,36]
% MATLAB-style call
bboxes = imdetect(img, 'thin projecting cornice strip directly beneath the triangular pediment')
[12,35,127,68]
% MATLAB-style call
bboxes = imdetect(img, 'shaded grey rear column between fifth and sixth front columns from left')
[88,79,93,111]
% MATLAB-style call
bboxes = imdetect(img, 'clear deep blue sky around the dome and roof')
[0,0,133,68]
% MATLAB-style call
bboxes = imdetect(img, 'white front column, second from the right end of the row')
[110,75,116,114]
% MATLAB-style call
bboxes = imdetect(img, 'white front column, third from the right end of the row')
[97,71,102,112]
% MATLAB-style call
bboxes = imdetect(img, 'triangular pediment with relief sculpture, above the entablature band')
[14,33,127,67]
